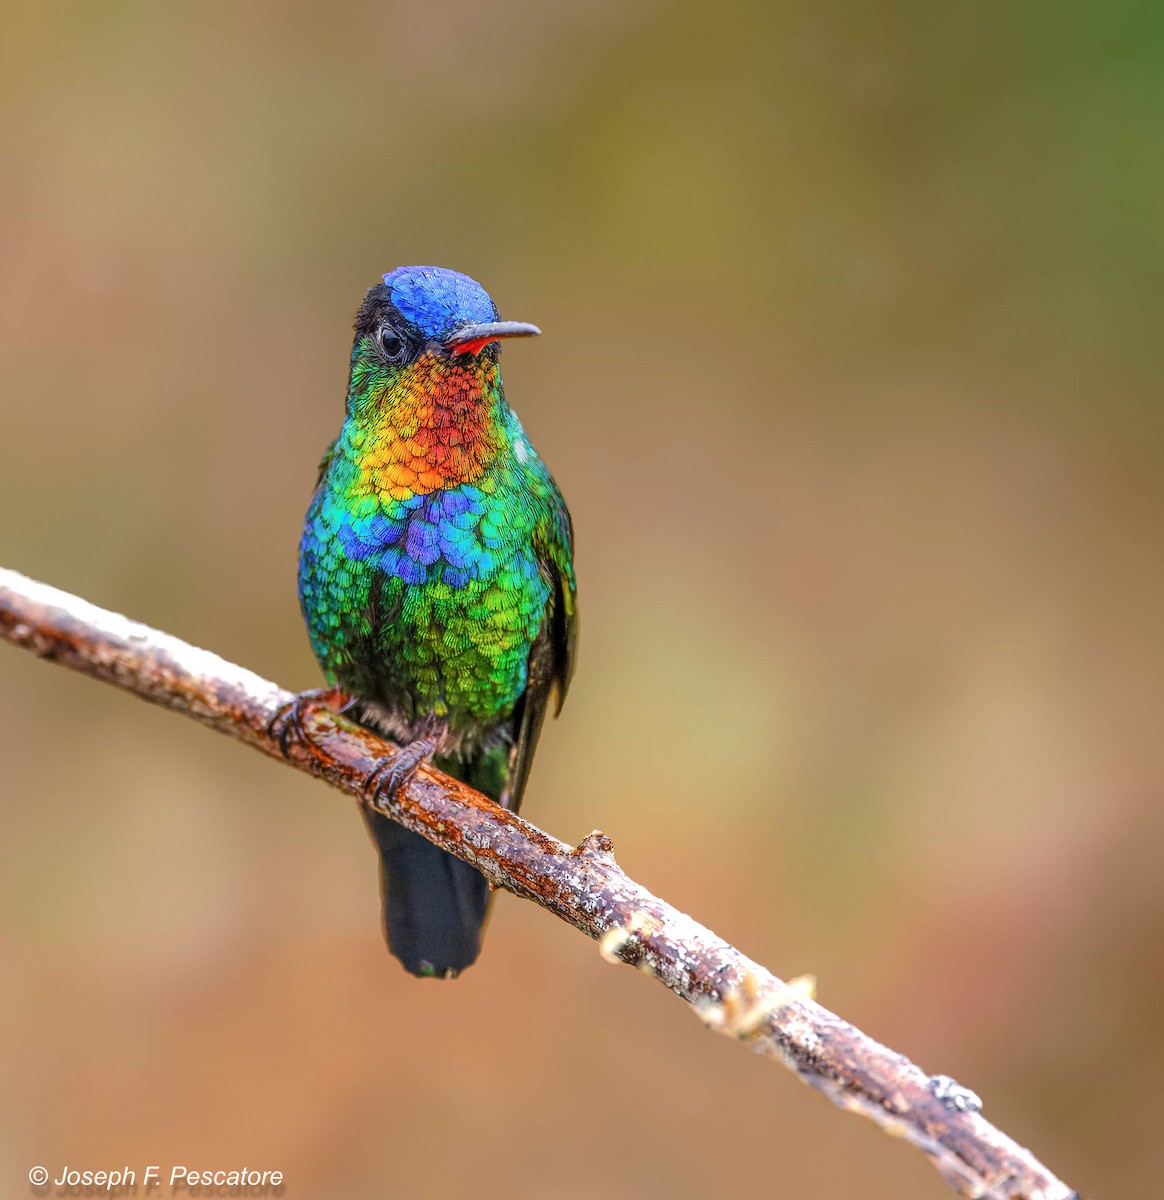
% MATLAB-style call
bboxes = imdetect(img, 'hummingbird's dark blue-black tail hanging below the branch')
[365,811,490,979]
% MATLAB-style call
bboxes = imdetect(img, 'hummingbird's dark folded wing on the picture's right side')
[502,496,578,812]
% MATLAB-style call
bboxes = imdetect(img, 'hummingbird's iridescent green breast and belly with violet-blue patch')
[292,419,564,734]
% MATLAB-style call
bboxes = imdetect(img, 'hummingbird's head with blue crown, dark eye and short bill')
[348,266,541,424]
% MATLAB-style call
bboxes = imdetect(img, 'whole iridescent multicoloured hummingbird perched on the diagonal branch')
[282,266,577,978]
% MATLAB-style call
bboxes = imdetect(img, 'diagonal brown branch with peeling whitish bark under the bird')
[0,569,1078,1200]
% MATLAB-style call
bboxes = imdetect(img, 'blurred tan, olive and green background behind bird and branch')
[0,0,1164,1200]
